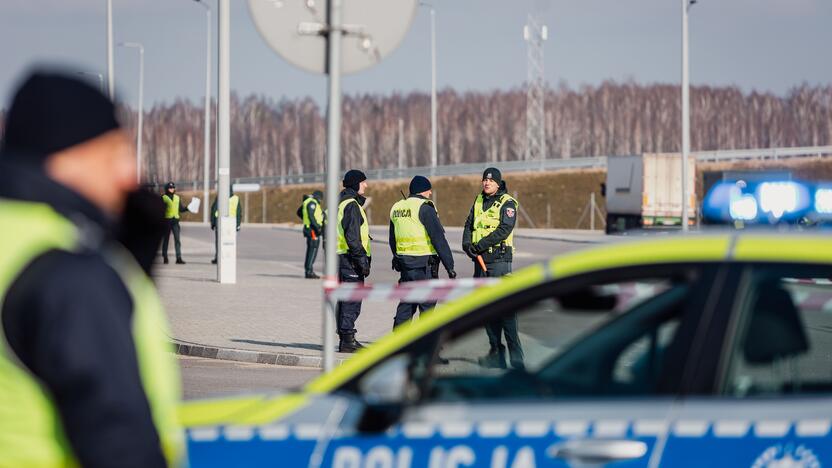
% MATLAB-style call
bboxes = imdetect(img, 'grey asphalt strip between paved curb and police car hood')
[179,356,321,400]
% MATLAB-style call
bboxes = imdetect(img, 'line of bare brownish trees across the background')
[0,81,832,181]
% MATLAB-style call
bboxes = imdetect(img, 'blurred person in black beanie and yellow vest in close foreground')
[0,71,185,468]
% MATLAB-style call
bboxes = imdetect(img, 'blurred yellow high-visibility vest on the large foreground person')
[0,199,185,467]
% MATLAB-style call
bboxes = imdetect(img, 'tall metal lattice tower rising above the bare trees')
[523,13,549,163]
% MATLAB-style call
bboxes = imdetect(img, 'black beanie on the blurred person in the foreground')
[0,71,119,164]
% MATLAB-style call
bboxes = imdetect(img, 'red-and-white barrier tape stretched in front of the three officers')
[324,278,499,302]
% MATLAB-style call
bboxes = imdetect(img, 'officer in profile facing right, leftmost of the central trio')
[337,169,371,353]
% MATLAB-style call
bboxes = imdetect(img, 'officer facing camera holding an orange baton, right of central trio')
[462,167,525,369]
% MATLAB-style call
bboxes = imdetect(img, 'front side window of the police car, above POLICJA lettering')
[424,270,698,401]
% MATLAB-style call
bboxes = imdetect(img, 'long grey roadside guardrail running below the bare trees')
[158,146,832,190]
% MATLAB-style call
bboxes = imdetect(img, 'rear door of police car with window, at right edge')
[661,263,832,467]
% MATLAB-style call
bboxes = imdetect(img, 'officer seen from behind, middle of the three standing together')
[389,176,456,328]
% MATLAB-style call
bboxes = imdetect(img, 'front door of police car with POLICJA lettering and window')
[319,264,719,468]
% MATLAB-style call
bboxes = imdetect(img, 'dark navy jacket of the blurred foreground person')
[0,160,165,467]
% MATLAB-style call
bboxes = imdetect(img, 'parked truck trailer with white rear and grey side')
[605,153,697,234]
